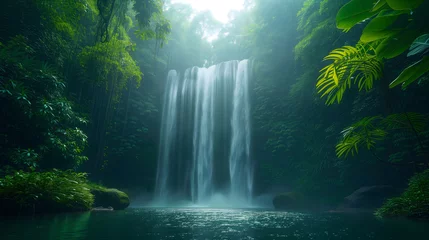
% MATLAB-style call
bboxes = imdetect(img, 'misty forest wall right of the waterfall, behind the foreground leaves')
[244,0,427,201]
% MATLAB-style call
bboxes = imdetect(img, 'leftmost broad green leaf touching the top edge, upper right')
[337,0,378,31]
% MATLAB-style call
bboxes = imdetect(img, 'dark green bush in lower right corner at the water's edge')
[375,170,429,219]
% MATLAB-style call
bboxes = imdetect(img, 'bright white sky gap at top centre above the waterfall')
[172,0,244,23]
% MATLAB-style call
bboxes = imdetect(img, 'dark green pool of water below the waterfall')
[0,208,429,240]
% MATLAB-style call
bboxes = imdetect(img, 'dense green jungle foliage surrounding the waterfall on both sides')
[0,0,429,216]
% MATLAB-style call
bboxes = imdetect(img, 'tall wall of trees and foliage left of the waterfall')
[0,0,171,190]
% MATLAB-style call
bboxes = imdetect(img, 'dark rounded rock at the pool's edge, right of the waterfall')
[339,186,400,209]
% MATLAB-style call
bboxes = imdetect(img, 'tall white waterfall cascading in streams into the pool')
[155,60,253,206]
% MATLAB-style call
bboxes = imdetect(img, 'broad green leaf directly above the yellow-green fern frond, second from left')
[360,10,407,42]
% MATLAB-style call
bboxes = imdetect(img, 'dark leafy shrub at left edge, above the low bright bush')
[0,36,87,170]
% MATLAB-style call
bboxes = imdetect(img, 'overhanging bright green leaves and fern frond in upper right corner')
[317,0,429,104]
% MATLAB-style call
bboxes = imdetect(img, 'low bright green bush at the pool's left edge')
[0,170,94,215]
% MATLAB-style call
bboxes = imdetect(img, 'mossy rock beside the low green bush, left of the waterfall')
[91,185,130,210]
